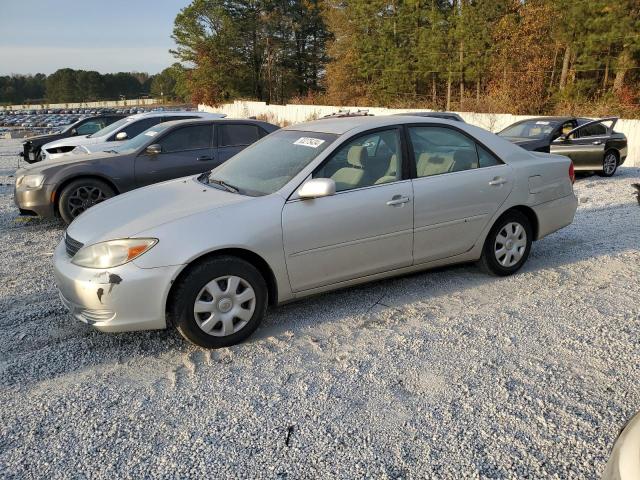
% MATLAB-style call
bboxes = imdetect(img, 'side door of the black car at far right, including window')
[551,121,608,169]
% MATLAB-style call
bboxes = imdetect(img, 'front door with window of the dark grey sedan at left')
[135,123,216,187]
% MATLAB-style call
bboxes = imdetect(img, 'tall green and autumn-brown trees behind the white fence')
[173,0,640,115]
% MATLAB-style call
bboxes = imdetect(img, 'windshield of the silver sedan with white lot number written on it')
[209,130,338,195]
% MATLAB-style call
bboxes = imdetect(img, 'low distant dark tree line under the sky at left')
[0,65,189,104]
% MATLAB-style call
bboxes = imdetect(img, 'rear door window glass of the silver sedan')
[409,127,478,177]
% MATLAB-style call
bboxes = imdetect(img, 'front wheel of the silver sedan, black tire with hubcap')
[167,256,268,348]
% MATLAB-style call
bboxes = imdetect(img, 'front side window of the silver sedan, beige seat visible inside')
[313,129,402,192]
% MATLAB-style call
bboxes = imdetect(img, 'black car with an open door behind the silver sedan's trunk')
[498,117,627,177]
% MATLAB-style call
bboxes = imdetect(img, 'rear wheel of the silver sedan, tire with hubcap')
[480,210,533,276]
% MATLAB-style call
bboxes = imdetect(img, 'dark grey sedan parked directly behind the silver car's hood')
[15,119,279,223]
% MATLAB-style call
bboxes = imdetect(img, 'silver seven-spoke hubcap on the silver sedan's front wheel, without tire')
[193,275,256,337]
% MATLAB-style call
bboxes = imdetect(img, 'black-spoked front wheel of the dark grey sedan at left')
[58,178,116,224]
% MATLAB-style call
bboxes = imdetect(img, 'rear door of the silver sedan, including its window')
[409,126,513,264]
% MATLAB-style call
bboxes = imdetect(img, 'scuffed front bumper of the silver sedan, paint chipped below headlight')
[53,241,181,332]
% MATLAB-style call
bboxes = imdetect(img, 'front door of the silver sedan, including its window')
[282,129,413,292]
